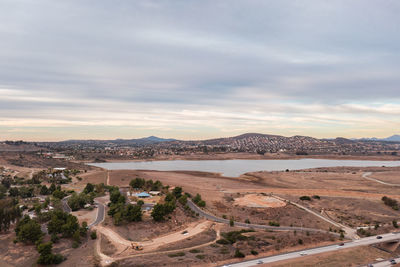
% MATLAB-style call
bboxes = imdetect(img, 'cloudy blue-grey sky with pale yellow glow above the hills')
[0,0,400,141]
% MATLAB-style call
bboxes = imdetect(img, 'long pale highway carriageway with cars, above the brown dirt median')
[223,233,400,267]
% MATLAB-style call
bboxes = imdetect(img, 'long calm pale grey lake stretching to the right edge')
[89,159,400,177]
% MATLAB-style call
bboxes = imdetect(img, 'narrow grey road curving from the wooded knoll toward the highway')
[187,200,339,235]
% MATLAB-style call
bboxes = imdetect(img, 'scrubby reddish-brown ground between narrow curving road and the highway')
[115,226,337,266]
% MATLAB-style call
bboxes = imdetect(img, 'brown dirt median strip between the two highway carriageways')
[266,247,391,267]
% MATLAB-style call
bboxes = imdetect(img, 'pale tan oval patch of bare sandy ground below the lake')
[234,194,286,208]
